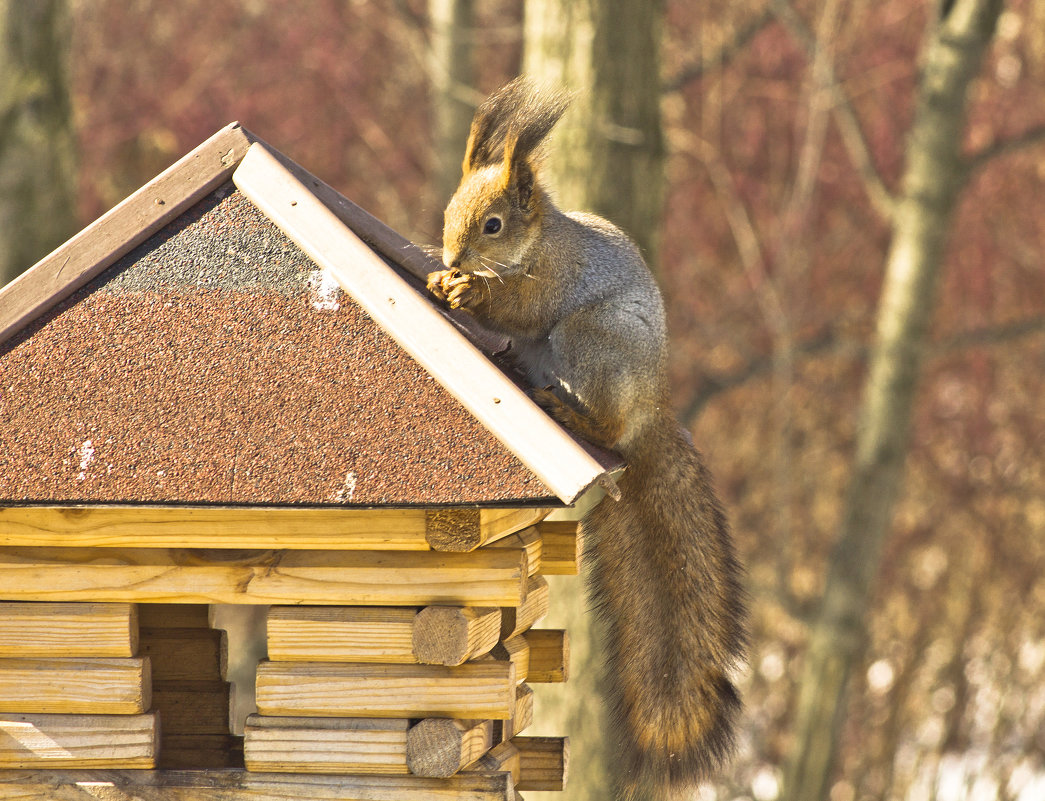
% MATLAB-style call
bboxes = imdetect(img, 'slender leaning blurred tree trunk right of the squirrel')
[784,0,1002,801]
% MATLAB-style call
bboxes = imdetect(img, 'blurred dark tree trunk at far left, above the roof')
[0,0,76,285]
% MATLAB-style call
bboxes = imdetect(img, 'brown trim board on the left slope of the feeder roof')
[0,122,256,343]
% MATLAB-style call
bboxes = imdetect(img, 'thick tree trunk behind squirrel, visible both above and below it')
[523,0,664,801]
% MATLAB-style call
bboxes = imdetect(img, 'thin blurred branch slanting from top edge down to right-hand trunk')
[772,0,896,219]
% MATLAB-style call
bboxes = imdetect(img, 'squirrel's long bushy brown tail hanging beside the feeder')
[582,416,746,799]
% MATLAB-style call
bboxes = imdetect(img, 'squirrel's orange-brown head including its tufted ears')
[443,78,567,278]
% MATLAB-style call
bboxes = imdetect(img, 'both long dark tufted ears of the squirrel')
[462,76,570,175]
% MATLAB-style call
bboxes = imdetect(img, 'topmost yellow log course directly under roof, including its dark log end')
[0,505,548,551]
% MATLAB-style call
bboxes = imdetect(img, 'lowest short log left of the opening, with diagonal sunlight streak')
[0,712,159,770]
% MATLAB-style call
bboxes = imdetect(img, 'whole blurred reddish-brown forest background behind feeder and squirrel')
[0,0,1045,801]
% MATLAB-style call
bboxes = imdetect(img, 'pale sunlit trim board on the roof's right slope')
[233,143,606,503]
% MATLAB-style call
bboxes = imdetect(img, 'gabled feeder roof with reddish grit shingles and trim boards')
[0,124,619,506]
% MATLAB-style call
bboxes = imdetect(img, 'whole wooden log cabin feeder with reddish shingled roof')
[0,124,620,801]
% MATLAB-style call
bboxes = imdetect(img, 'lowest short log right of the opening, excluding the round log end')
[243,714,410,776]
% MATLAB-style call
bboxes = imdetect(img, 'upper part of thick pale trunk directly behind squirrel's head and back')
[524,0,665,269]
